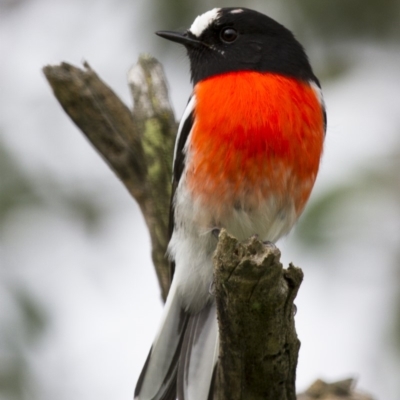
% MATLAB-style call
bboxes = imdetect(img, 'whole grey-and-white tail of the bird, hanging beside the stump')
[134,285,219,400]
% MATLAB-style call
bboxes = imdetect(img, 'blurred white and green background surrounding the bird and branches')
[0,0,400,400]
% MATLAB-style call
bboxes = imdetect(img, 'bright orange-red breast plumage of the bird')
[187,71,324,217]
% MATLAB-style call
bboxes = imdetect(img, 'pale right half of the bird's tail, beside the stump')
[177,302,219,400]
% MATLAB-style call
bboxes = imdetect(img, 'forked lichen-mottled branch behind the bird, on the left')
[43,56,176,300]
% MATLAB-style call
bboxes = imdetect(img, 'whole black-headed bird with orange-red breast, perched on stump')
[134,7,327,400]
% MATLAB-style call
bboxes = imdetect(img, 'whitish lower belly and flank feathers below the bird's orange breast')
[169,182,297,312]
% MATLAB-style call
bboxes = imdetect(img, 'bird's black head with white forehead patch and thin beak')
[157,8,318,84]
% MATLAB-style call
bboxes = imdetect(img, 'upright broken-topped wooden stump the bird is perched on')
[214,231,303,400]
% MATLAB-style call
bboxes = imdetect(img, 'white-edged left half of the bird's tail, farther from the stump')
[134,287,189,400]
